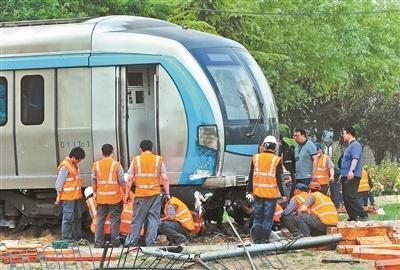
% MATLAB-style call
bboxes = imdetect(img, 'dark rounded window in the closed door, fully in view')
[21,75,44,125]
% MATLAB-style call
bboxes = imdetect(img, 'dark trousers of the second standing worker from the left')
[94,202,122,246]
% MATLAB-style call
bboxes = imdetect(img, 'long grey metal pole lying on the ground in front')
[200,234,342,261]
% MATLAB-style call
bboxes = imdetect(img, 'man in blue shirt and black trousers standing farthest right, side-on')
[340,127,368,221]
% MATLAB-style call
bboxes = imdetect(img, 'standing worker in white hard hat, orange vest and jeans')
[246,136,286,244]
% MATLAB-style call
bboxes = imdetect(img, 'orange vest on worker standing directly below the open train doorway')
[132,152,163,197]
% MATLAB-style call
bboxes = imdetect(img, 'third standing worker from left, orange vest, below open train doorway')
[124,140,170,246]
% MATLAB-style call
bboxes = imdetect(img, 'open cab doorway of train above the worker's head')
[126,66,158,158]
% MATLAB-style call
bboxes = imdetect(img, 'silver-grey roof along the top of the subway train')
[0,16,242,57]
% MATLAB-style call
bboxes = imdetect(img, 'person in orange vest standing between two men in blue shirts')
[315,143,335,195]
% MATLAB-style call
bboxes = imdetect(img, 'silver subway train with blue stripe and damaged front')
[0,16,278,228]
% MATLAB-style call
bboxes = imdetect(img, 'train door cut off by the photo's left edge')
[0,71,16,177]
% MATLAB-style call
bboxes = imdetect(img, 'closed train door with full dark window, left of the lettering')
[15,69,57,175]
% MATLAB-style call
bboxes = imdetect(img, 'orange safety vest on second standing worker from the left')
[92,158,122,204]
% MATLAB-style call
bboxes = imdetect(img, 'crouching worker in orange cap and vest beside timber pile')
[292,182,339,237]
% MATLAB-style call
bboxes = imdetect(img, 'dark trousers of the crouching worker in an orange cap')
[292,213,327,237]
